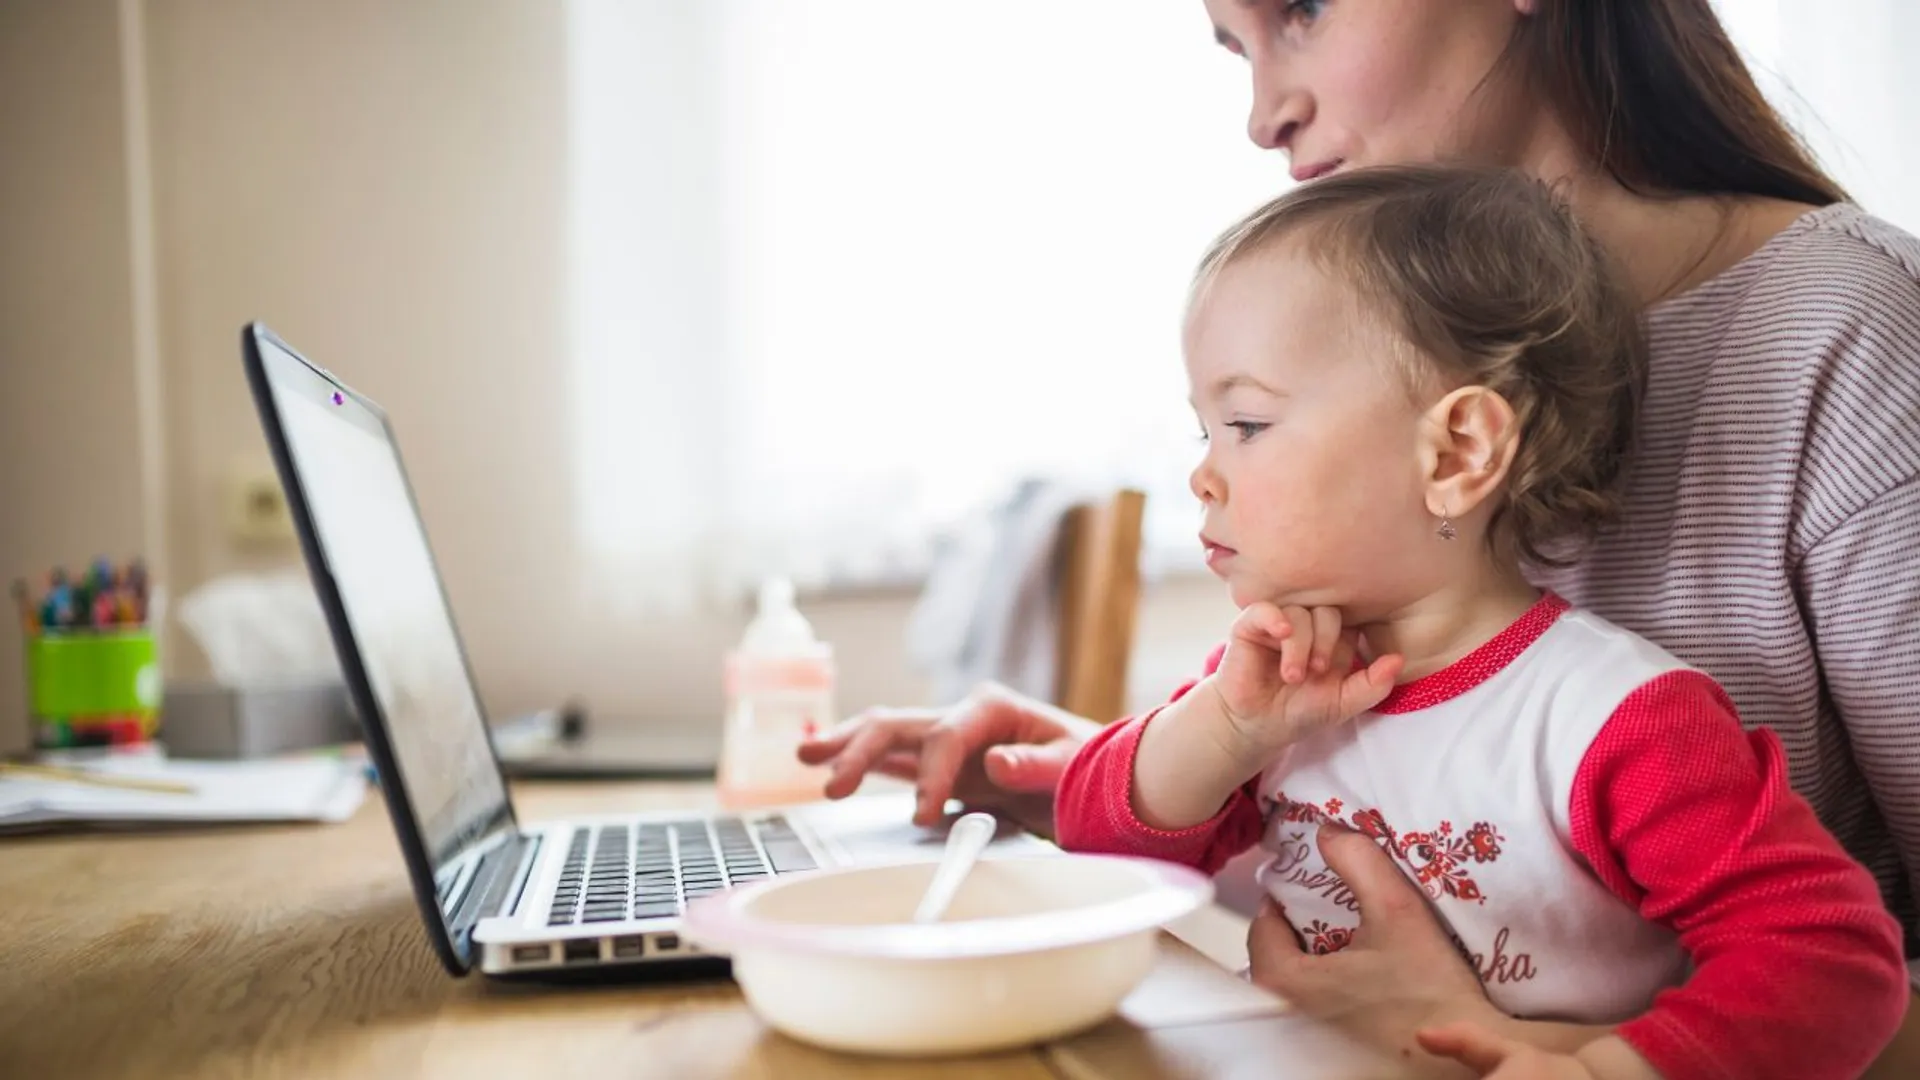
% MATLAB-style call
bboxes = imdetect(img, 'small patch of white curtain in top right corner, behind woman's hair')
[1715,0,1920,233]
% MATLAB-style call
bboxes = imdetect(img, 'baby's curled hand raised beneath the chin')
[1208,603,1402,767]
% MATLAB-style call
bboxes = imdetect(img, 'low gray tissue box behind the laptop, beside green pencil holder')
[159,682,361,757]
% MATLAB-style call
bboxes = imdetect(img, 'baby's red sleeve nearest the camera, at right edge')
[1569,671,1908,1080]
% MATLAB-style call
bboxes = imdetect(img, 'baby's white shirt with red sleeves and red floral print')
[1056,596,1908,1080]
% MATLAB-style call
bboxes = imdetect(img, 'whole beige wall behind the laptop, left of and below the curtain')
[0,0,1227,757]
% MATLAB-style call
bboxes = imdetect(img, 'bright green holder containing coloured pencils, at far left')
[27,630,161,748]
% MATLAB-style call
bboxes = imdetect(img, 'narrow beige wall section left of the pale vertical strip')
[0,0,150,753]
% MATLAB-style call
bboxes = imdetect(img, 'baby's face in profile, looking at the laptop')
[1185,244,1438,621]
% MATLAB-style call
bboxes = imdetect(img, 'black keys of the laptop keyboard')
[547,815,814,926]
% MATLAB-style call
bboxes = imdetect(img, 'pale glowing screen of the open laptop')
[259,328,511,864]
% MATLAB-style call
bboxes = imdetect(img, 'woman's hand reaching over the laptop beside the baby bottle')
[801,684,1100,832]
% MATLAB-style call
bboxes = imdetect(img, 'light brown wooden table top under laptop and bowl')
[0,784,1443,1080]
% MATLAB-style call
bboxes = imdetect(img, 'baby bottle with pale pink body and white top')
[718,578,833,809]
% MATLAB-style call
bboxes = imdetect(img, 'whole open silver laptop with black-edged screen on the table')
[242,323,1056,980]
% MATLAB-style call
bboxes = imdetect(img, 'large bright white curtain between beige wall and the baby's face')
[570,0,1288,601]
